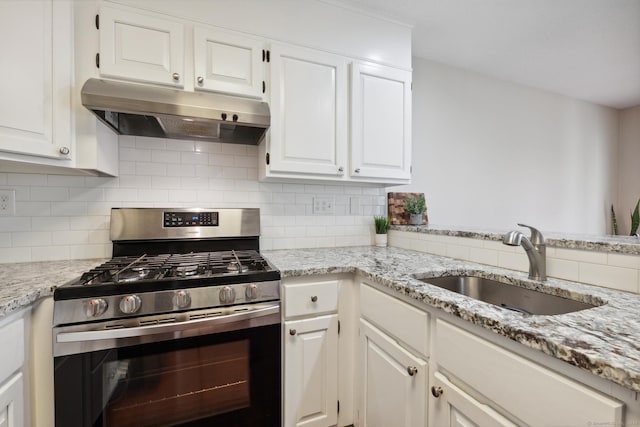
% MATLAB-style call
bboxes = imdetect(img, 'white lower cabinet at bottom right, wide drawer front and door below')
[430,319,624,427]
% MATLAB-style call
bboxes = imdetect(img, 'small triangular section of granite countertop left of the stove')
[0,259,105,317]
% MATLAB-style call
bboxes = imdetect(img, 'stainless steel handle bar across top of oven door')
[56,304,280,343]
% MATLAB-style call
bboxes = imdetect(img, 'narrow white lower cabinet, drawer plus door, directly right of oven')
[283,280,339,427]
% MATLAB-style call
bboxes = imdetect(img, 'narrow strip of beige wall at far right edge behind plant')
[615,106,640,234]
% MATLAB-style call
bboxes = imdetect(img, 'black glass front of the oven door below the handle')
[55,325,280,427]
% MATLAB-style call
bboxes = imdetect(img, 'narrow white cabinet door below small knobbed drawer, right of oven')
[284,314,338,427]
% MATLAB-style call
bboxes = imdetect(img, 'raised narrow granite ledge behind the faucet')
[390,225,640,255]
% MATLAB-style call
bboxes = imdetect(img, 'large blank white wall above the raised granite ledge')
[396,57,618,234]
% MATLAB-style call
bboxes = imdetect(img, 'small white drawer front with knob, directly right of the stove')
[284,280,338,319]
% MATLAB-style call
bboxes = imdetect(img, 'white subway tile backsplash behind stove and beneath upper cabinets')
[0,137,386,263]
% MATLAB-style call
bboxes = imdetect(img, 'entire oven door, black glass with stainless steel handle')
[54,303,281,427]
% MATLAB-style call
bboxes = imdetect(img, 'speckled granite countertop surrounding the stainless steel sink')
[264,247,640,391]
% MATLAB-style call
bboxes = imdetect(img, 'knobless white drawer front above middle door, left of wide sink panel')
[360,284,429,356]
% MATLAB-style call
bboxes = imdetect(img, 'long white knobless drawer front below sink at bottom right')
[435,320,623,426]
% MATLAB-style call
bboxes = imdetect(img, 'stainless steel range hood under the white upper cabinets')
[82,79,271,145]
